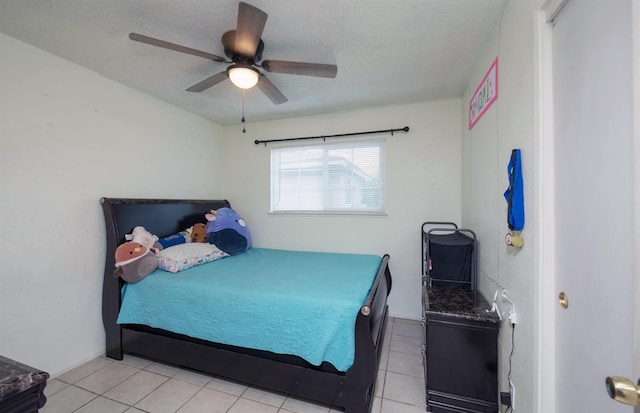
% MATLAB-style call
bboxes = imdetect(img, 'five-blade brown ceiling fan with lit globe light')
[129,2,338,105]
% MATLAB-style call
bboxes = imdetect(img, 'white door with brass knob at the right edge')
[552,0,640,413]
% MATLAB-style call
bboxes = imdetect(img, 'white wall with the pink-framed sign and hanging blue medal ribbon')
[462,1,542,411]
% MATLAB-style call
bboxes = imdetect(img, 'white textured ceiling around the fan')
[0,0,506,124]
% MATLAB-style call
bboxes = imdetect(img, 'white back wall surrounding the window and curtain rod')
[220,99,461,319]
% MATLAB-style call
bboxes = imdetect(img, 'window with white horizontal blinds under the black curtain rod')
[271,140,384,213]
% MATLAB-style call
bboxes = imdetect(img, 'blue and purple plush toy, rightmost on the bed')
[205,208,251,255]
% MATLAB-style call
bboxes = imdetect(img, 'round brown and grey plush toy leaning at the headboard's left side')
[113,241,158,283]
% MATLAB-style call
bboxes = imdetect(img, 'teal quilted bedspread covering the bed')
[118,248,381,371]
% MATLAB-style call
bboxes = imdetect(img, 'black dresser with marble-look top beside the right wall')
[422,285,500,413]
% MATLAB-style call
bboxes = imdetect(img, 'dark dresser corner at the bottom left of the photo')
[0,356,49,413]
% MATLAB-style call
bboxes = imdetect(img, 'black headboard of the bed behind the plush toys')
[100,198,231,352]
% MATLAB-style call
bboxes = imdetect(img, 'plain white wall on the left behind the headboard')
[0,34,223,375]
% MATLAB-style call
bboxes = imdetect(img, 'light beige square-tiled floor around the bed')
[40,318,425,413]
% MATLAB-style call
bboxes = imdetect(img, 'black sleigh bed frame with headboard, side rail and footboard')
[100,198,391,413]
